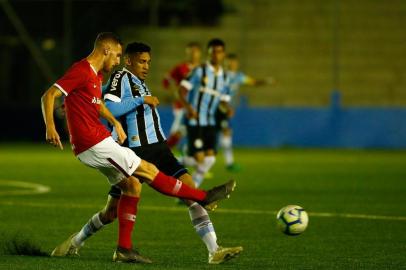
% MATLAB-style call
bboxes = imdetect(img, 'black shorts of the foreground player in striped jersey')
[109,141,188,198]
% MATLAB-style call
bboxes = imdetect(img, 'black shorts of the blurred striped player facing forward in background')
[187,126,218,156]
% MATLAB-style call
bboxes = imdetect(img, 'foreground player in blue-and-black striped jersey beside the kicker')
[53,42,242,264]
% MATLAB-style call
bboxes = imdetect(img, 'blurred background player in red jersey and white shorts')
[162,42,202,148]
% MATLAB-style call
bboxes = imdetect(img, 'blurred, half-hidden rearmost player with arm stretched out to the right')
[216,54,274,171]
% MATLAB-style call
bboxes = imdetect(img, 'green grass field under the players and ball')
[0,144,406,269]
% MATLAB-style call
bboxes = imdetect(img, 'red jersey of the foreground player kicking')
[55,59,111,155]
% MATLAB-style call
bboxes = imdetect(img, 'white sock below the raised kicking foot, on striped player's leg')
[189,203,218,253]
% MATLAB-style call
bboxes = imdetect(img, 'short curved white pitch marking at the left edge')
[0,179,51,195]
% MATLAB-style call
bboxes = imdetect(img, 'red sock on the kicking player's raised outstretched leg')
[149,172,206,201]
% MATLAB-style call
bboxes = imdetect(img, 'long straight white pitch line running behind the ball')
[0,201,406,221]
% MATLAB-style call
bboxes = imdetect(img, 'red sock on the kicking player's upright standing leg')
[117,195,140,249]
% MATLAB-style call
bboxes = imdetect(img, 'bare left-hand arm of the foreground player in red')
[41,86,63,150]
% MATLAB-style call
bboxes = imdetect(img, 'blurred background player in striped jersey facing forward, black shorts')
[179,39,232,186]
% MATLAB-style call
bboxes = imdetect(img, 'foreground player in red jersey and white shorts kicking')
[41,32,235,263]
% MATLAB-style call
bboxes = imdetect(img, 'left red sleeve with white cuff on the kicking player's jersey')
[54,64,87,96]
